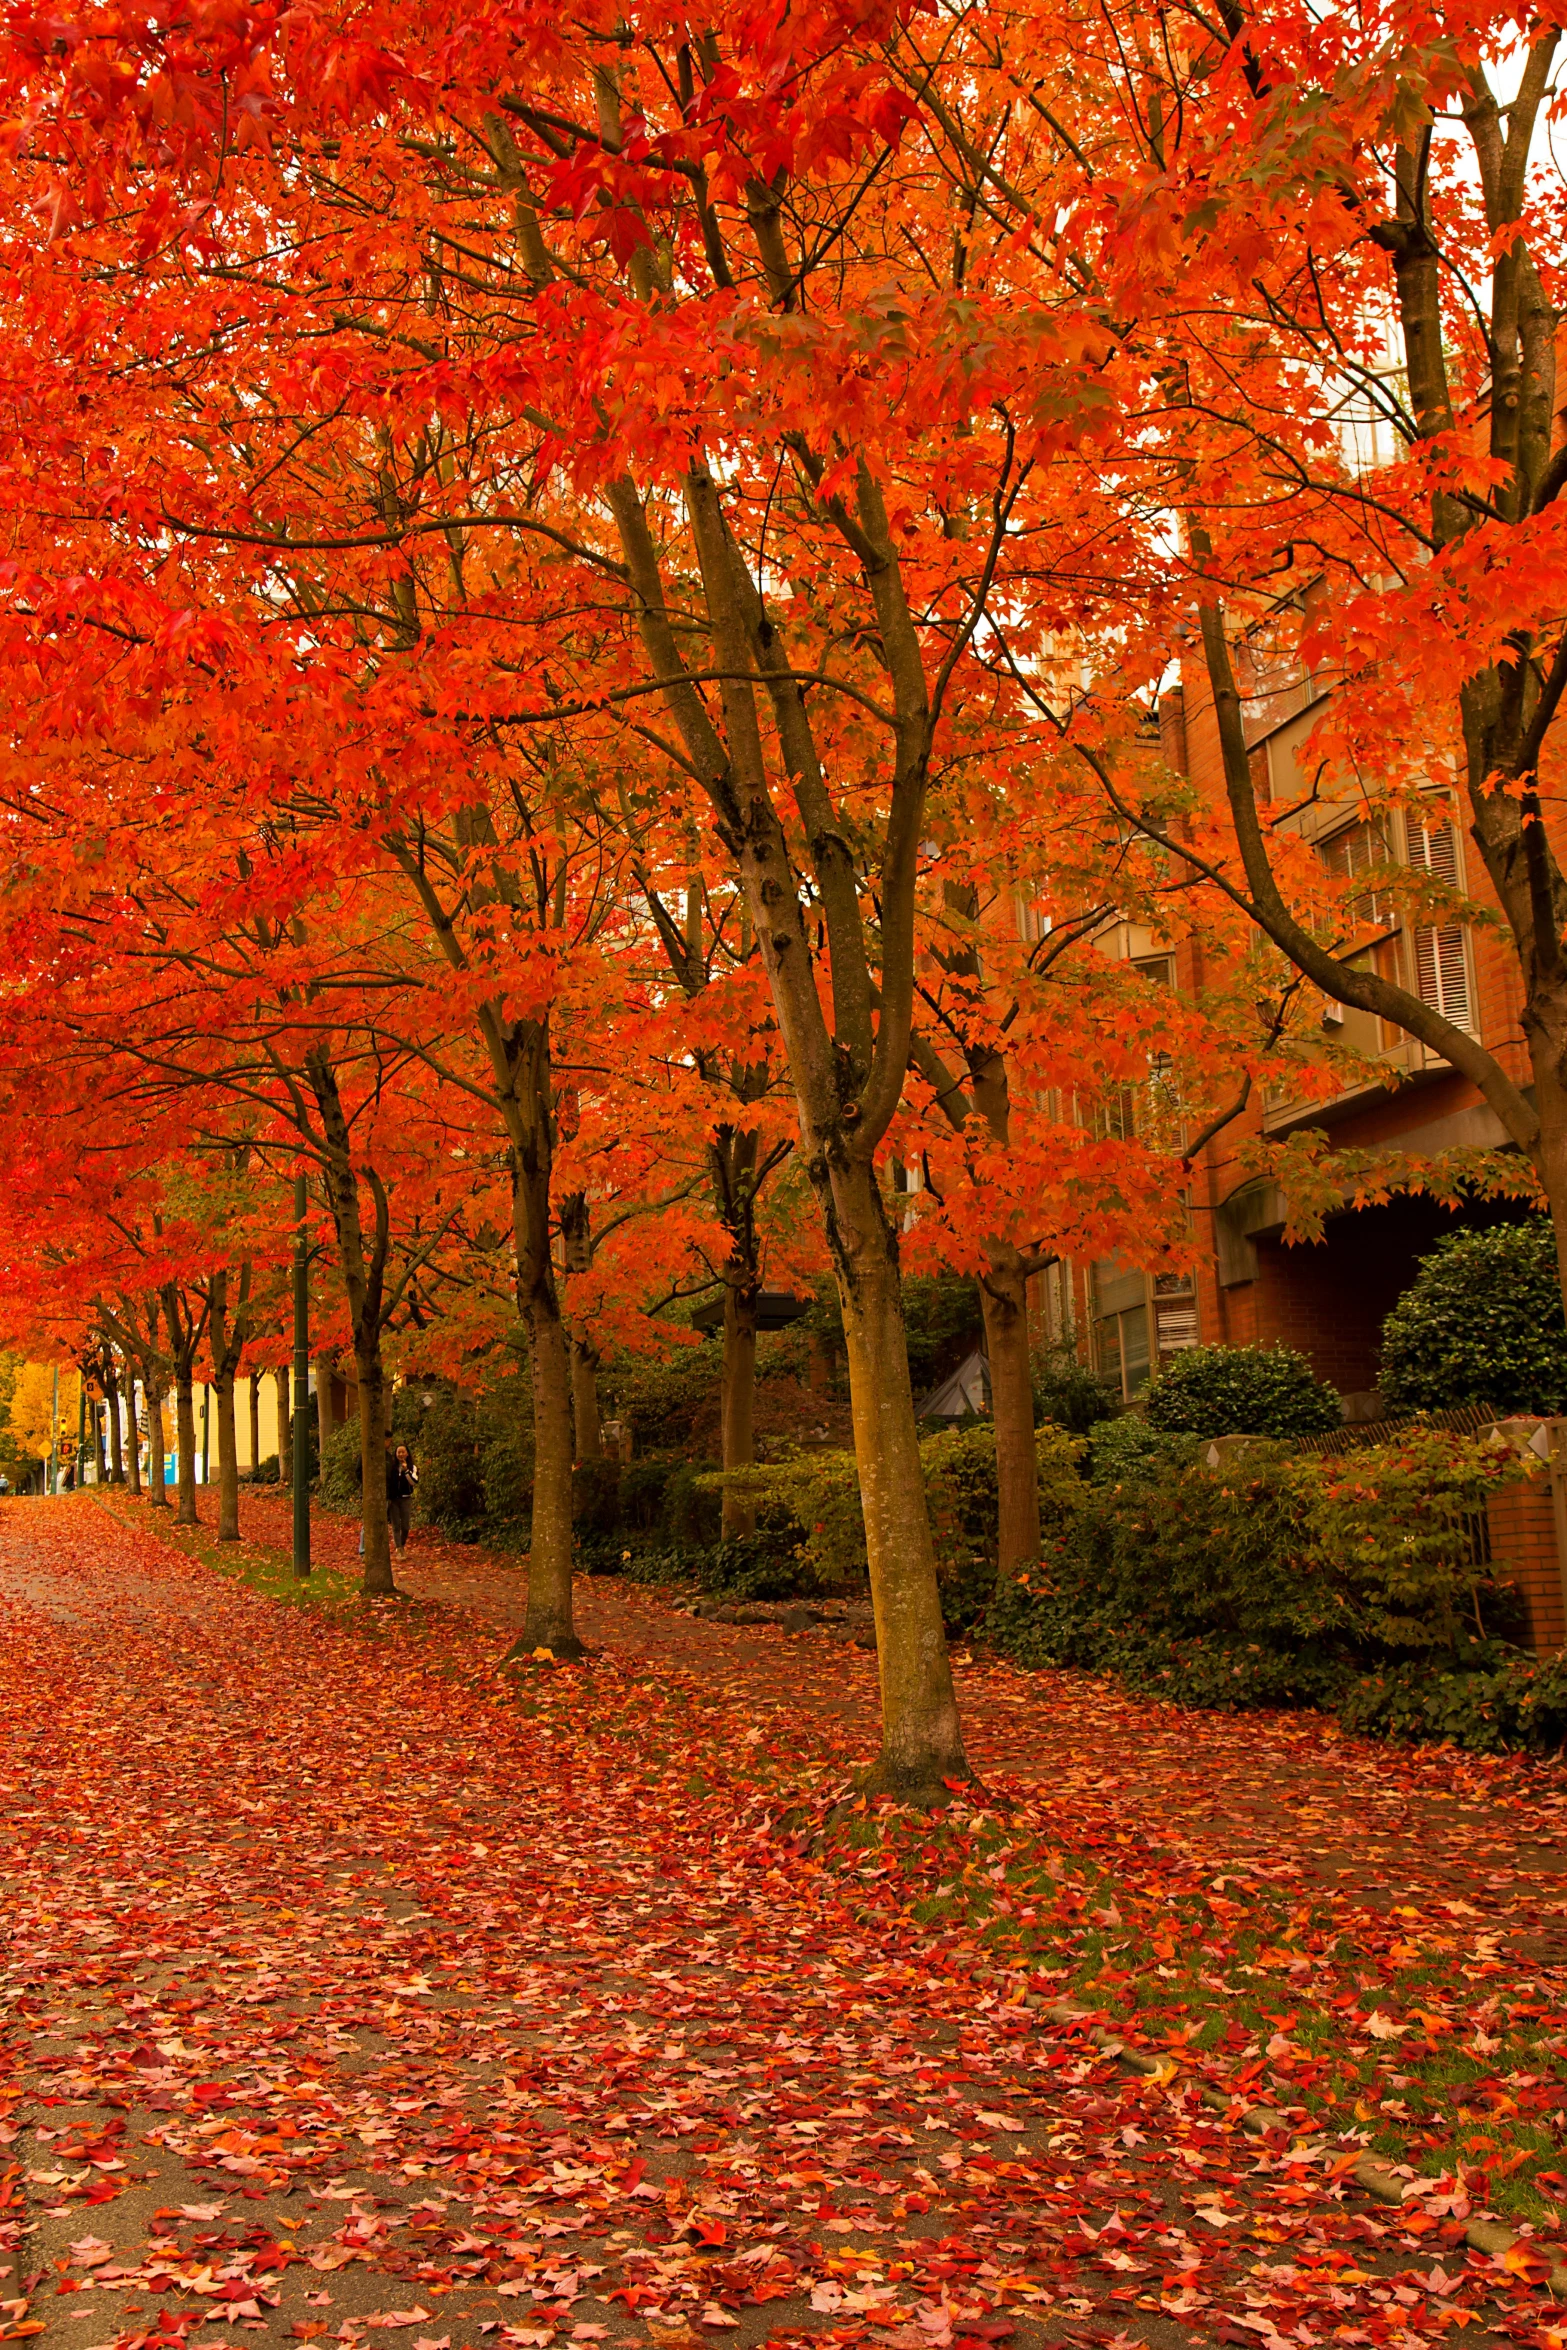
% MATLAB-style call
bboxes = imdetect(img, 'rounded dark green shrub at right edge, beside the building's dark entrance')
[1379,1215,1567,1412]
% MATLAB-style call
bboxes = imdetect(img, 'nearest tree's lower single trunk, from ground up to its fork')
[827,1159,973,1798]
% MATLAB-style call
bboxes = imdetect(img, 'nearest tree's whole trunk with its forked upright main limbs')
[604,458,973,1802]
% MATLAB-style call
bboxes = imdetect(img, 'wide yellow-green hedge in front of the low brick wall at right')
[987,1426,1560,1746]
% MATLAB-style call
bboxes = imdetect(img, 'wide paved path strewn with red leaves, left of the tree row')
[0,1499,1544,2350]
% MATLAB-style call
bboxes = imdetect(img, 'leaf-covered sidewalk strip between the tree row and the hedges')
[247,1497,1567,1969]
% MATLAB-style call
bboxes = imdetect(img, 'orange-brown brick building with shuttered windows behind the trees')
[1041,634,1529,1419]
